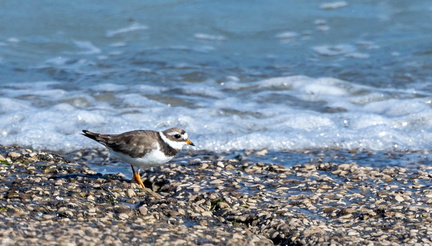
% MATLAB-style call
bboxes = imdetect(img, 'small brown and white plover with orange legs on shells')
[82,127,195,192]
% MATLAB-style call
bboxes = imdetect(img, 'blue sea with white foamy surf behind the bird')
[0,0,432,165]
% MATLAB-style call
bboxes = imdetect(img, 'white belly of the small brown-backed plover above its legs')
[110,150,174,168]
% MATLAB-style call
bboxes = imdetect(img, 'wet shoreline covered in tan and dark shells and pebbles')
[0,145,432,245]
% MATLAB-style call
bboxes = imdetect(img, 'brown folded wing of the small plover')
[83,130,162,158]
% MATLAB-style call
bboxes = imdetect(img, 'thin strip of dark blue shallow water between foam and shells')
[71,149,432,179]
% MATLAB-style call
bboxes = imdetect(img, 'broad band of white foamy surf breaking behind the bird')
[0,76,432,151]
